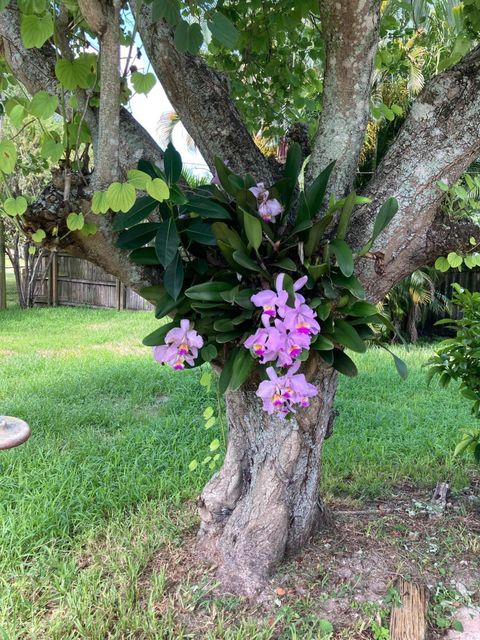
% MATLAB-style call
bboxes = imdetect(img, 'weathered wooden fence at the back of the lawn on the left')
[35,253,153,311]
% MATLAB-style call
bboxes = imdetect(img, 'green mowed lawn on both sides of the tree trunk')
[0,308,471,640]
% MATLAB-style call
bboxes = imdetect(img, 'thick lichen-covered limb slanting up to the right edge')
[350,47,480,299]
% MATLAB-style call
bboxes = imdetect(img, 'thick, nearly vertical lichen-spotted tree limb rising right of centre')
[308,0,380,198]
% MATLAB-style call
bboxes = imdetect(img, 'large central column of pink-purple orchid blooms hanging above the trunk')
[244,274,320,416]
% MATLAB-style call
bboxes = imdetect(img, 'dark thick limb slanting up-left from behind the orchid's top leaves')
[135,3,275,182]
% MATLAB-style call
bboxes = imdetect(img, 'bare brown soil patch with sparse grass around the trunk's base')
[139,487,480,640]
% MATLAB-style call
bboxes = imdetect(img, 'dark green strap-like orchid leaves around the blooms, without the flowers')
[114,144,404,391]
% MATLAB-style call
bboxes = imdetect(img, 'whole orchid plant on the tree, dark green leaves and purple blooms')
[132,144,403,417]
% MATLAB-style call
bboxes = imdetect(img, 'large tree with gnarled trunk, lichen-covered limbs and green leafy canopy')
[0,0,480,595]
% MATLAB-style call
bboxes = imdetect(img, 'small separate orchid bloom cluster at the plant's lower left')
[153,320,203,370]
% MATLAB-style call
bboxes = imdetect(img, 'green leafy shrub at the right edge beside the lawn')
[428,283,480,462]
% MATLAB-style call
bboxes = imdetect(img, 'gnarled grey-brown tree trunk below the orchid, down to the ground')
[198,365,337,597]
